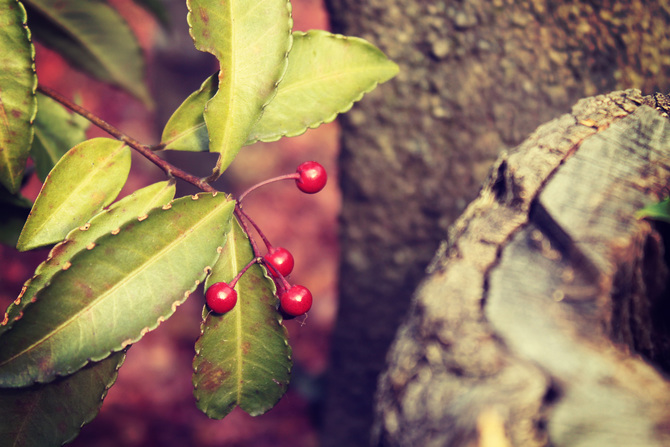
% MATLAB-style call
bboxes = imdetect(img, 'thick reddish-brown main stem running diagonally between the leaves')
[37,85,216,192]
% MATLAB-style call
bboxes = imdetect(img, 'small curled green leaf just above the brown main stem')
[161,75,219,152]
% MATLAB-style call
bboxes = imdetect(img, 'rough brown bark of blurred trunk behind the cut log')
[322,0,670,447]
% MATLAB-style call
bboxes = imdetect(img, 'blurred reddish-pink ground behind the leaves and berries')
[0,0,339,447]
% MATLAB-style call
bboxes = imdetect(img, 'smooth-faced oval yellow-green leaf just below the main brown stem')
[17,138,131,251]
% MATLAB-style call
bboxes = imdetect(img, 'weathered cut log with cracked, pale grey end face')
[373,90,670,447]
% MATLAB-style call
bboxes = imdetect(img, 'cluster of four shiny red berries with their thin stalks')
[205,161,328,319]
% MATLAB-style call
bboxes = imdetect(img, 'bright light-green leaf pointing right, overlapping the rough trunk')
[246,30,398,144]
